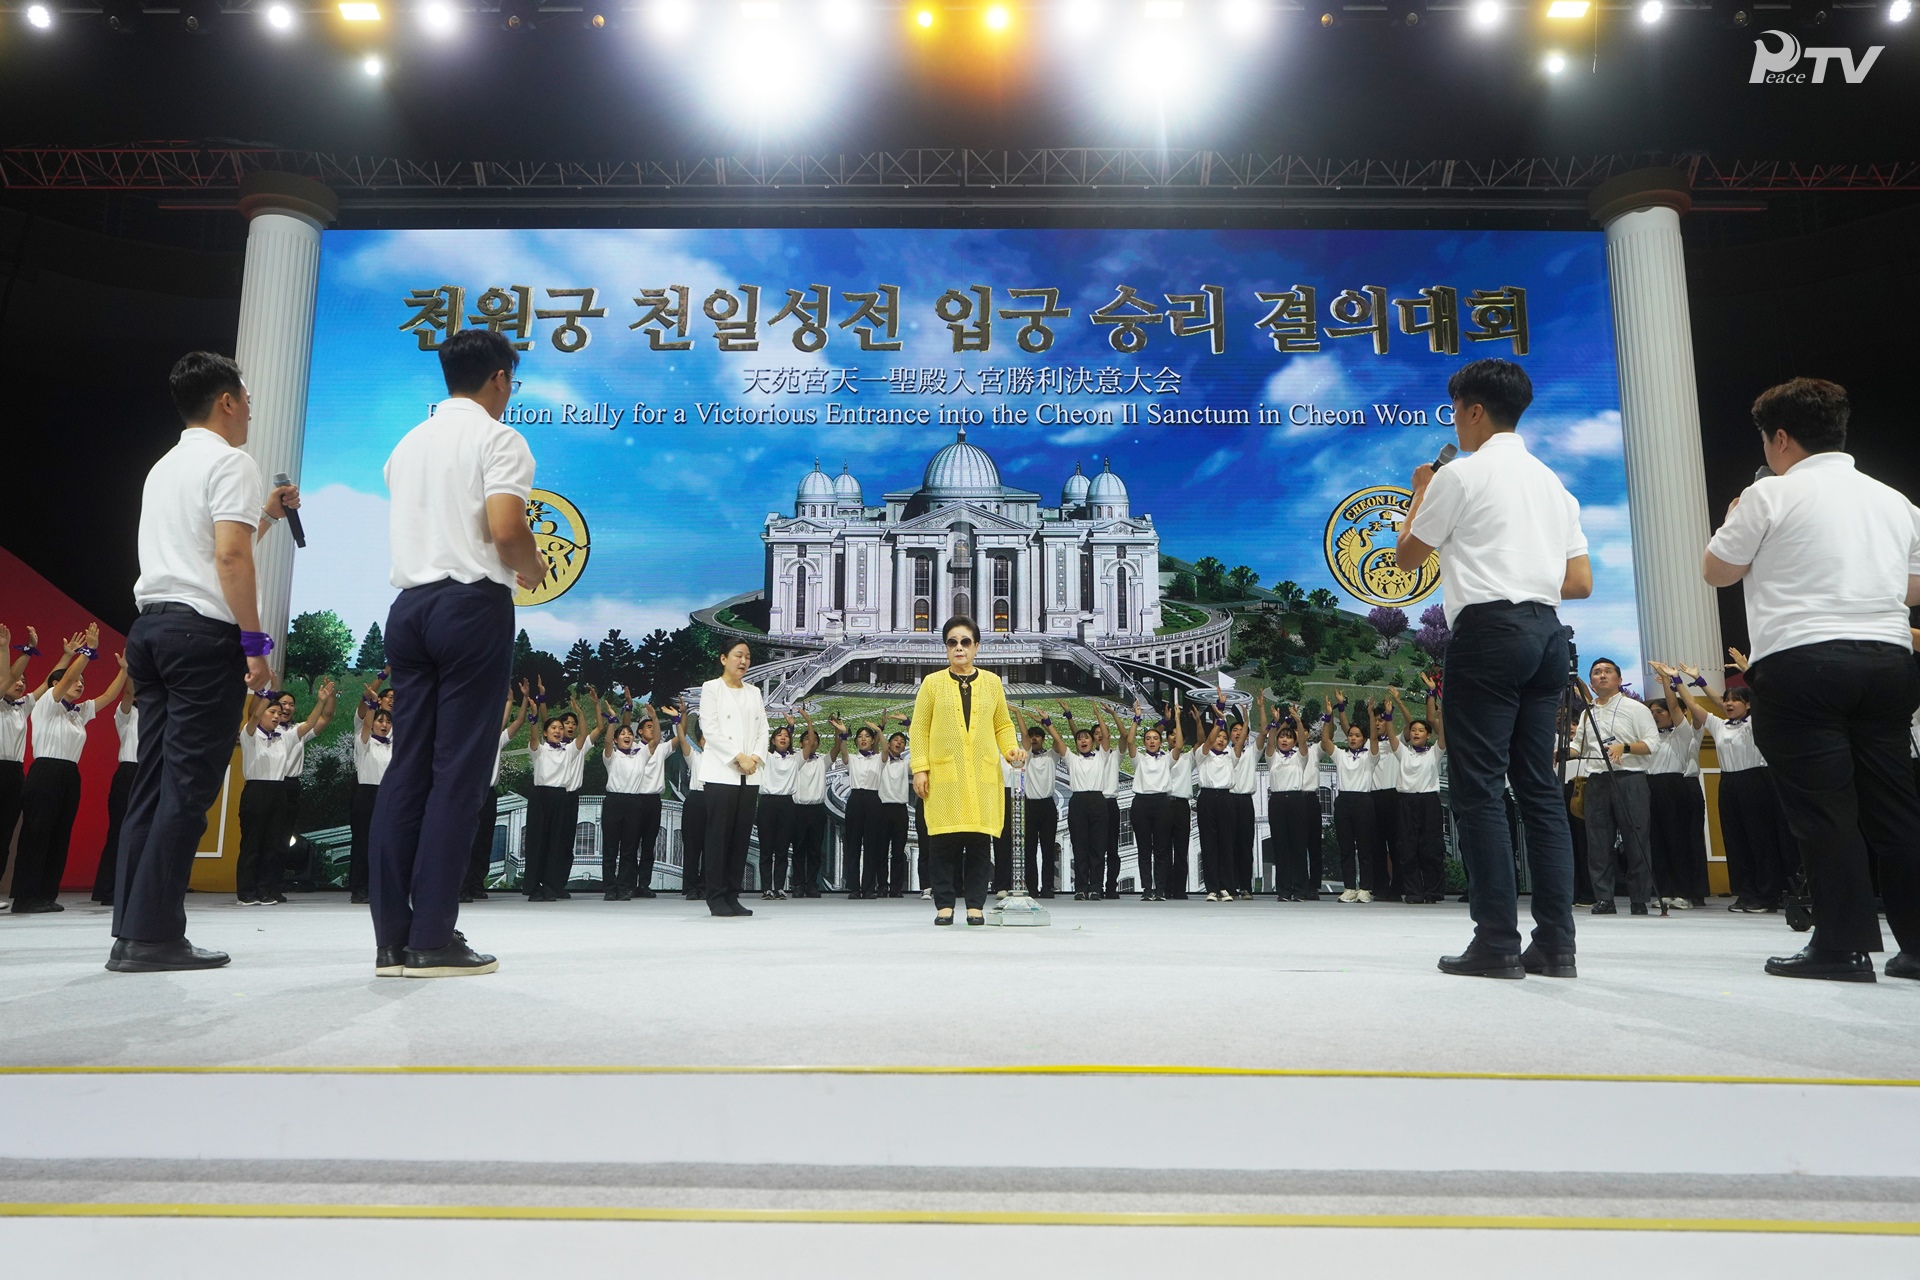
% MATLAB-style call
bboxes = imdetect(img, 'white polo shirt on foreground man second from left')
[386,397,534,589]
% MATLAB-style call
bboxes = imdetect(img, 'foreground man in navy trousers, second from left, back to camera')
[369,330,547,979]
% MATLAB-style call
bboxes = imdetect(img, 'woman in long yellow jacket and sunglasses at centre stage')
[908,616,1027,925]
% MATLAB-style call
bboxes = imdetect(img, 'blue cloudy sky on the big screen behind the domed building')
[294,230,1640,670]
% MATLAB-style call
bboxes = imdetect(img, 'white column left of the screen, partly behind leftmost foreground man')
[234,173,340,672]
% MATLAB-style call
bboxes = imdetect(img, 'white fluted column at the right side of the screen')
[1588,169,1724,687]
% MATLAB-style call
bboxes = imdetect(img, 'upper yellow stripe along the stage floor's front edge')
[0,1063,1920,1088]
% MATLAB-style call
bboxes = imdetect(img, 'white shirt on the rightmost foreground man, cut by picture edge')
[1707,453,1920,662]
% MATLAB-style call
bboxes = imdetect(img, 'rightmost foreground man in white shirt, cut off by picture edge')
[1701,378,1920,983]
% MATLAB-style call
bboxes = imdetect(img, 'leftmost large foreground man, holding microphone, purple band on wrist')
[108,351,300,973]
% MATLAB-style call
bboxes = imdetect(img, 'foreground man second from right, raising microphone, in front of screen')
[1396,361,1594,979]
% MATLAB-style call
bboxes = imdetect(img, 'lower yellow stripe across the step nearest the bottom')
[0,1201,1920,1236]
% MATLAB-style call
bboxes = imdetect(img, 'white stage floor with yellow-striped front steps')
[0,894,1920,1280]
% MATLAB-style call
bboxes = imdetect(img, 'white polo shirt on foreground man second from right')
[1413,432,1586,626]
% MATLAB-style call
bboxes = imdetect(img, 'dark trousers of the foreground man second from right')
[1446,603,1574,956]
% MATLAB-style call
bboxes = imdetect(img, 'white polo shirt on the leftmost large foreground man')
[132,426,267,622]
